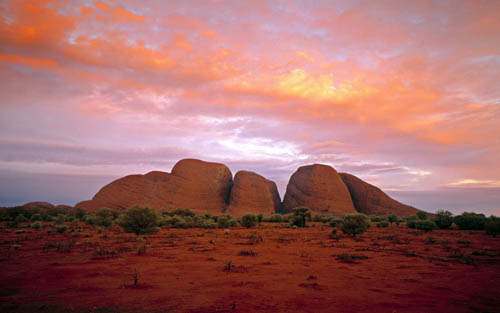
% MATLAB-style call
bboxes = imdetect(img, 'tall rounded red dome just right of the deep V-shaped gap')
[283,164,356,214]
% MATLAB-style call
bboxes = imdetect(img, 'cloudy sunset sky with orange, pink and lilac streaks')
[0,0,500,214]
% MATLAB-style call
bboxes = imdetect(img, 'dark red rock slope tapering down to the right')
[339,173,418,216]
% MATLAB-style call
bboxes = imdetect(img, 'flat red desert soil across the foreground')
[0,224,500,313]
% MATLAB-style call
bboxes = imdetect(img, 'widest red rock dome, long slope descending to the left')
[75,159,232,214]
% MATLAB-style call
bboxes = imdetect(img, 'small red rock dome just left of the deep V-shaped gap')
[227,171,281,217]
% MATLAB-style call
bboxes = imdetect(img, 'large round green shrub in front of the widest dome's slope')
[117,206,160,236]
